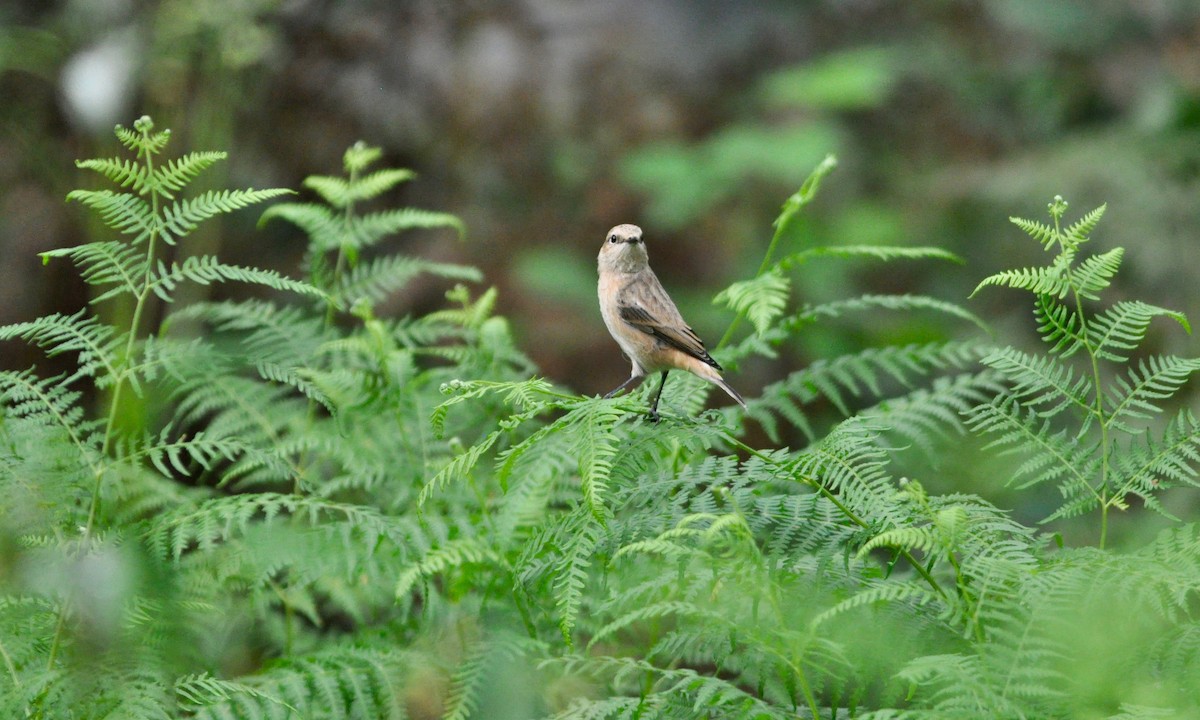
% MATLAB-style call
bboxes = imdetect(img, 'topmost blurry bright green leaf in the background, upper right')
[760,48,895,110]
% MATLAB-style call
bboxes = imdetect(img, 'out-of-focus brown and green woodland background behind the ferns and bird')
[0,0,1200,415]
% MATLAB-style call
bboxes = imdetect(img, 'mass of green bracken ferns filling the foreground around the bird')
[0,118,1200,720]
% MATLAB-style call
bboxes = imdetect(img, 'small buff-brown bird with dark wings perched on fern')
[596,224,746,420]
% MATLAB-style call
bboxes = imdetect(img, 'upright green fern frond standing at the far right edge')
[971,197,1200,547]
